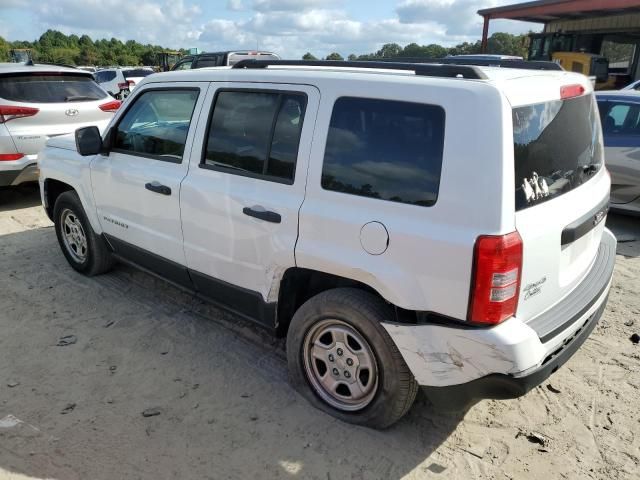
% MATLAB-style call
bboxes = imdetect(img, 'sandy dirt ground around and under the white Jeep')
[0,188,640,480]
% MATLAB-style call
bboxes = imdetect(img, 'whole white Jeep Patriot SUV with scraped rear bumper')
[39,61,616,428]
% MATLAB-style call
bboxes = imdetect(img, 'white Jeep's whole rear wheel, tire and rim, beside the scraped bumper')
[287,288,418,428]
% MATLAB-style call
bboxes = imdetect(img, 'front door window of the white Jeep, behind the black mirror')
[113,90,198,162]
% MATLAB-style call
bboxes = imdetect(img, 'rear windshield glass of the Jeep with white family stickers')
[513,95,603,210]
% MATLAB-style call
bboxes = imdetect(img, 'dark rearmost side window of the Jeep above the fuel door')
[322,97,445,206]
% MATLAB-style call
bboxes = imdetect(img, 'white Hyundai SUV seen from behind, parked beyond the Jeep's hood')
[0,63,120,187]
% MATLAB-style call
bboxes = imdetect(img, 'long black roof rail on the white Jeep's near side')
[232,59,487,80]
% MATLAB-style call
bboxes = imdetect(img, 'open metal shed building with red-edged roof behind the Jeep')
[478,0,640,84]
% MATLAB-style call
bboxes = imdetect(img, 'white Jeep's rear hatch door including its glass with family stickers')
[512,93,610,321]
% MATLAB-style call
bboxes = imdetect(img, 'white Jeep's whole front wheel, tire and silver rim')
[53,191,113,276]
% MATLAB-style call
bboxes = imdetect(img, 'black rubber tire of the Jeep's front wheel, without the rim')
[53,190,114,276]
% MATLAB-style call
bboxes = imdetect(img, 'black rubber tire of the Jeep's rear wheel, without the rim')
[287,288,418,429]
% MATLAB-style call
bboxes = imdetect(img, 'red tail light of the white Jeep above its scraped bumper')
[467,232,522,325]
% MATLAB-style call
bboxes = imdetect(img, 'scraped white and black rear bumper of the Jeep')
[383,229,616,408]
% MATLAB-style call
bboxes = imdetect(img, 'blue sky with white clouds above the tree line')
[0,0,541,58]
